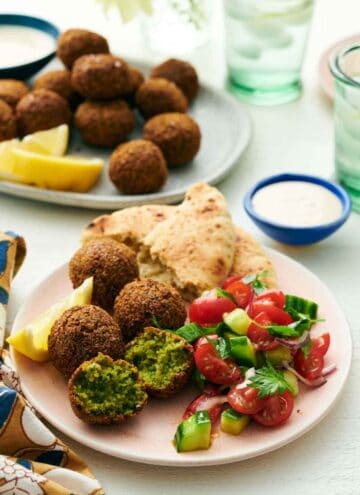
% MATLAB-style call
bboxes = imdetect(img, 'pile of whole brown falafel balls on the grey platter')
[0,29,201,194]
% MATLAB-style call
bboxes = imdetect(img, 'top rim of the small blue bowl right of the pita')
[243,172,351,233]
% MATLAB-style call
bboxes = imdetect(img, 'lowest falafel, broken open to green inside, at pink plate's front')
[68,353,148,425]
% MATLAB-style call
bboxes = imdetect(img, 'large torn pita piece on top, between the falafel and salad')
[138,183,235,298]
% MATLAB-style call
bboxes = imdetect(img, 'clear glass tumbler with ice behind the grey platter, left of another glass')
[224,0,314,105]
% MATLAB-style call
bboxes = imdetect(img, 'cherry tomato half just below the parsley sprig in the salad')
[253,390,294,426]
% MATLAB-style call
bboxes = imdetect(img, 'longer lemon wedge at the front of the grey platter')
[8,147,104,192]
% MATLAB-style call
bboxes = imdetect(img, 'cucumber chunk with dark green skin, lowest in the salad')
[174,411,211,452]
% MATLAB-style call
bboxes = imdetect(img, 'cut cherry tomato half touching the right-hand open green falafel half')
[194,339,241,385]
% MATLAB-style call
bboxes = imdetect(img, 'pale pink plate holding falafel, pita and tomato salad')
[13,250,352,466]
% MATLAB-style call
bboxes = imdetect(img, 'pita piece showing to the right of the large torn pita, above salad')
[230,226,277,287]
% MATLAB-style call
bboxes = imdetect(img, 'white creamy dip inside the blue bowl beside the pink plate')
[252,181,343,227]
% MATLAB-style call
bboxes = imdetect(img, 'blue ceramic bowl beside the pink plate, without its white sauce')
[244,174,351,246]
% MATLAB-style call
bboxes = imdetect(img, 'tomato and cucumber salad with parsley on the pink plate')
[174,274,336,452]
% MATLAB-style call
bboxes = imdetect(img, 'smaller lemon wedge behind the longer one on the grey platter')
[21,124,69,156]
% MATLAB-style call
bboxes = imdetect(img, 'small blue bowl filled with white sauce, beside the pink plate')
[244,174,351,246]
